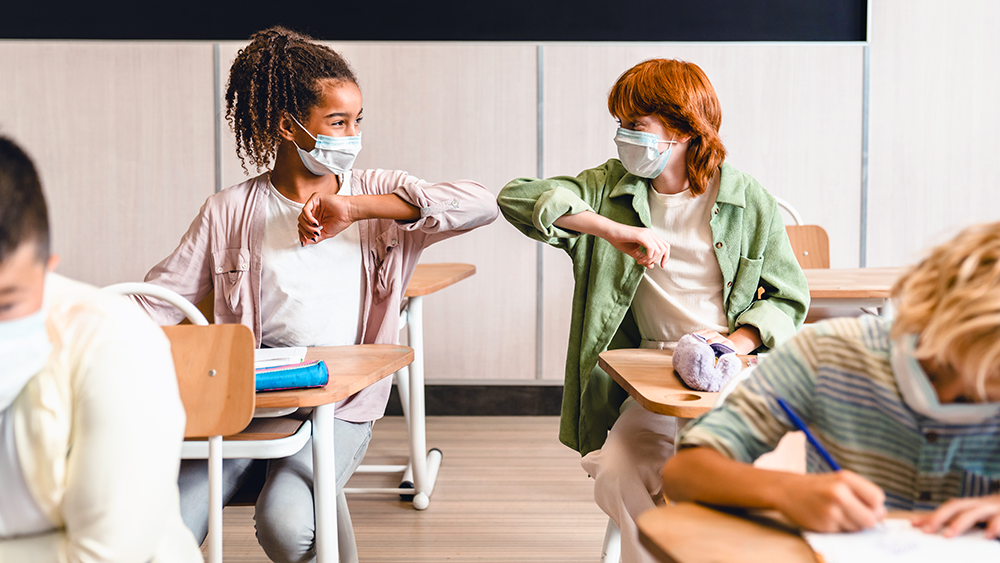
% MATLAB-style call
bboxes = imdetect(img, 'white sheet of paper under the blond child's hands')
[802,519,1000,563]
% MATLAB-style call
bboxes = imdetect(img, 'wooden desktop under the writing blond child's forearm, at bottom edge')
[636,502,817,563]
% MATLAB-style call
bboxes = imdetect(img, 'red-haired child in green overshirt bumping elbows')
[499,59,809,562]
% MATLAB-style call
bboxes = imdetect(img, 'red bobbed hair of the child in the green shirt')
[608,59,726,195]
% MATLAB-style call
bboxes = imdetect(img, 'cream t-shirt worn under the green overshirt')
[632,174,729,347]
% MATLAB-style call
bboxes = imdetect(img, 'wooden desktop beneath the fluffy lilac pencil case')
[597,348,747,418]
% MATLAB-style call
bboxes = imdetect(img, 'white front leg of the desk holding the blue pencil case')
[313,403,340,563]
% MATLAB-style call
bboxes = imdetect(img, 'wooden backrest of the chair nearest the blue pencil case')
[163,324,254,438]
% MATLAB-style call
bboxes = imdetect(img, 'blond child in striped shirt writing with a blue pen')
[663,223,1000,537]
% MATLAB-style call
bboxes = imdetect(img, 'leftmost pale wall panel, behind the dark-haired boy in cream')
[0,41,213,285]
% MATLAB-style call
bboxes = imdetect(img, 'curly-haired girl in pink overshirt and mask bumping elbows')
[140,27,499,562]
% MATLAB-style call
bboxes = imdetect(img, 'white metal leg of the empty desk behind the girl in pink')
[406,297,441,510]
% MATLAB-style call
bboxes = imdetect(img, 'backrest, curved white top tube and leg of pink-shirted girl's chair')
[104,283,255,563]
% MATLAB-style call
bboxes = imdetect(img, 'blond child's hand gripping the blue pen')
[775,470,886,533]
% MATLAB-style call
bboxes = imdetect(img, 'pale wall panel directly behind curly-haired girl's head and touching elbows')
[221,43,536,380]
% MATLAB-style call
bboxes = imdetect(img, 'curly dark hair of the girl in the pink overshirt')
[226,27,358,172]
